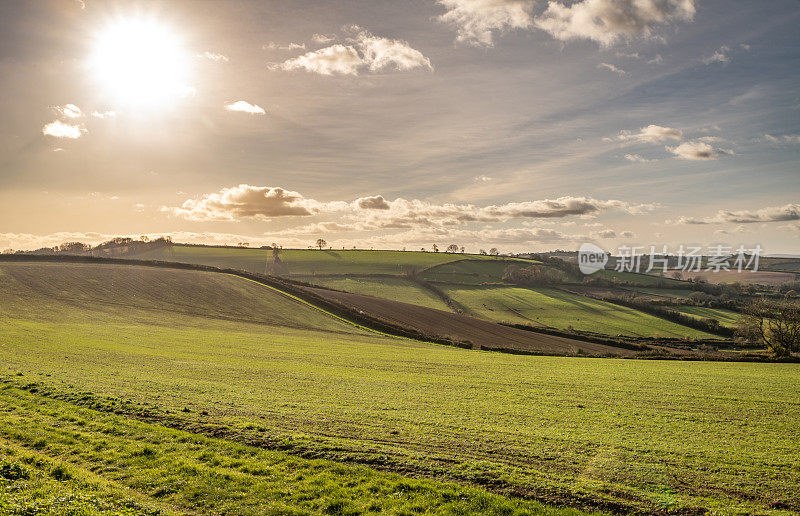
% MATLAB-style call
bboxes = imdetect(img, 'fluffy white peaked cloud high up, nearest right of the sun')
[270,26,433,75]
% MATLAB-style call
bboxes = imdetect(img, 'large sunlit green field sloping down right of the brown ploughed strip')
[441,285,715,338]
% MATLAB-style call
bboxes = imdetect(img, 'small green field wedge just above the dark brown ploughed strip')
[309,277,450,312]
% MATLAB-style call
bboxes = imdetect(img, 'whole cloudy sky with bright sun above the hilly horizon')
[0,0,800,254]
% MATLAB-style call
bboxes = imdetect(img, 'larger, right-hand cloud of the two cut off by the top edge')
[535,0,695,46]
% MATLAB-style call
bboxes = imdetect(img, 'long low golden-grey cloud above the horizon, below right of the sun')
[161,184,347,221]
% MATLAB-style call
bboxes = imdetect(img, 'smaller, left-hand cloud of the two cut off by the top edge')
[439,0,533,47]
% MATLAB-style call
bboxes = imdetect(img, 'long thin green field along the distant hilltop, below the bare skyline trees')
[133,245,490,275]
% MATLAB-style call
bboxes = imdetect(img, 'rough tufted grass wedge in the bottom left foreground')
[0,385,578,516]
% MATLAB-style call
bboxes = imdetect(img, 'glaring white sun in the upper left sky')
[89,18,192,108]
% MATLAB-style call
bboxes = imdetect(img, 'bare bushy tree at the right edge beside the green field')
[736,297,800,357]
